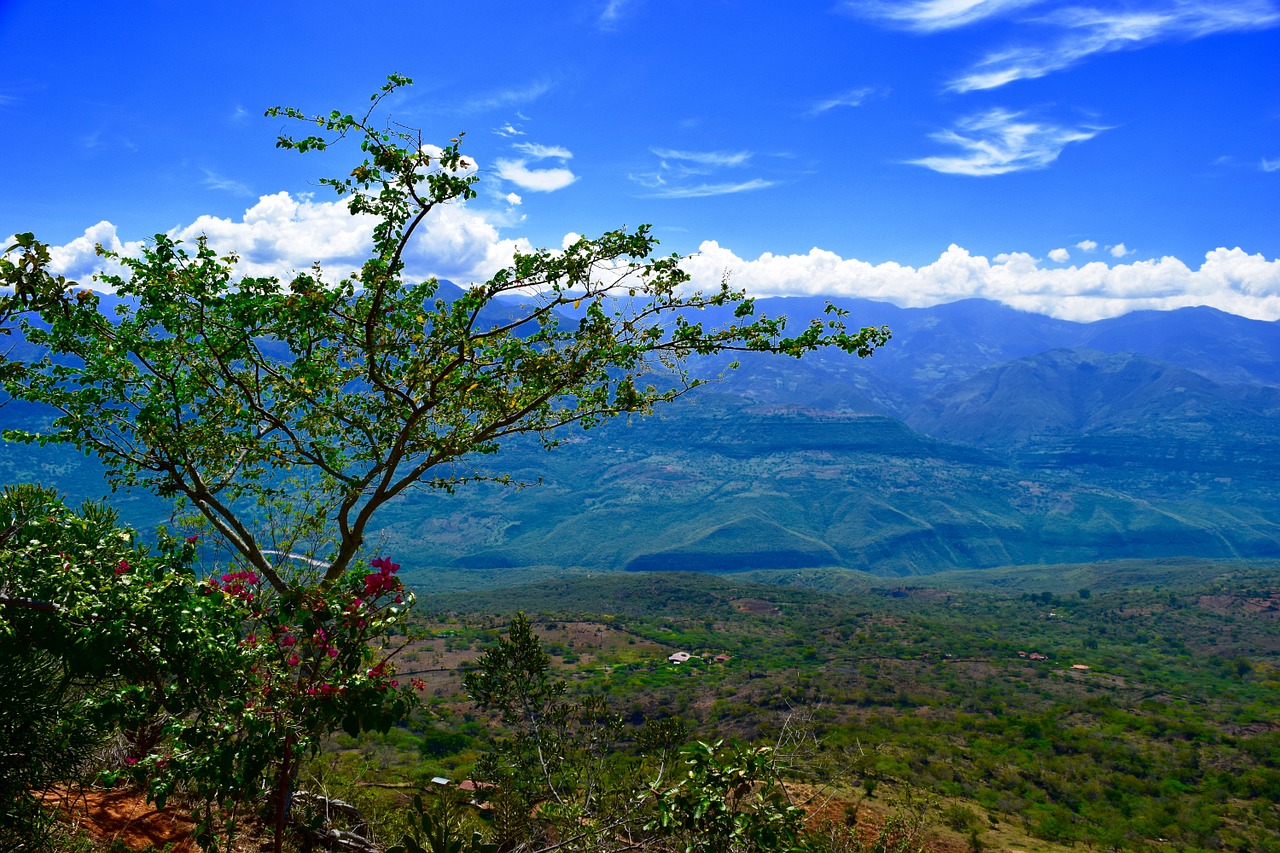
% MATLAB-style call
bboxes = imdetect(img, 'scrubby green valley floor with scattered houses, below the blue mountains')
[391,564,1280,850]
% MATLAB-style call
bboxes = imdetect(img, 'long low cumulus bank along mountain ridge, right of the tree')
[684,241,1280,321]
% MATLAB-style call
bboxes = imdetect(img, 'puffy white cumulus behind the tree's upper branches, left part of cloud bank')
[40,192,531,283]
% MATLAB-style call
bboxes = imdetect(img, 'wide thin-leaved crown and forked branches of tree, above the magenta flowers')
[0,76,888,590]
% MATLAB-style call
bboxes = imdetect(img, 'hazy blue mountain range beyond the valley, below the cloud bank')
[0,292,1280,578]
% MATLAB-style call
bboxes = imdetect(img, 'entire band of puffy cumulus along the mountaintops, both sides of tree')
[35,220,1280,321]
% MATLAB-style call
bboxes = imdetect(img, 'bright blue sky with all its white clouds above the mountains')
[0,0,1280,319]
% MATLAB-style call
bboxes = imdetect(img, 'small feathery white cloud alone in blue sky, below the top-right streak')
[908,109,1106,177]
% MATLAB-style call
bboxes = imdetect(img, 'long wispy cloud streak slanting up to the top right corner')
[947,0,1280,92]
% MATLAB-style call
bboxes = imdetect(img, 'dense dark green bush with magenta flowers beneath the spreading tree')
[0,487,413,843]
